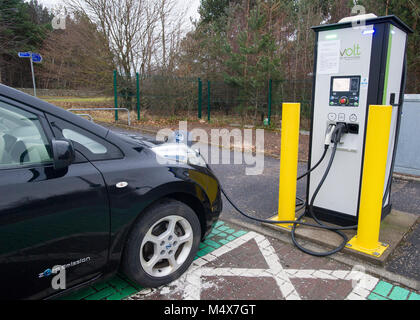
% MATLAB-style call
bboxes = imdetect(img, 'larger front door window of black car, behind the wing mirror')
[0,101,53,169]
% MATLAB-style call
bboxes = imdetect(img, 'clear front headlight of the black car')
[151,143,207,167]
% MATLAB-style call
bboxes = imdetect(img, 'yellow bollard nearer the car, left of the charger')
[278,103,300,229]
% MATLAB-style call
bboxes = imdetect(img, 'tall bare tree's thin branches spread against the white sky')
[67,0,188,75]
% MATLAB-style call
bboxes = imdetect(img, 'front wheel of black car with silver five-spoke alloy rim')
[122,199,201,288]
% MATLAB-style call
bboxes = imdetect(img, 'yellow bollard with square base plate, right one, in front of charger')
[347,106,392,257]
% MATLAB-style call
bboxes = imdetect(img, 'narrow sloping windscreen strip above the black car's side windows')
[0,84,109,138]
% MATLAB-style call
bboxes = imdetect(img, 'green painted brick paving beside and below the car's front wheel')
[59,221,248,300]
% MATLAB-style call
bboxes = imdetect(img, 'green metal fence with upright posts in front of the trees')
[114,72,312,124]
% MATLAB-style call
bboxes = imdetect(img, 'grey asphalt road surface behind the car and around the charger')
[107,128,420,280]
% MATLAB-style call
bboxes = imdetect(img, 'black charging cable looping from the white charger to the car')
[213,124,357,257]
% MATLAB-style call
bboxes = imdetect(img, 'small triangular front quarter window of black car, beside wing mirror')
[48,115,124,161]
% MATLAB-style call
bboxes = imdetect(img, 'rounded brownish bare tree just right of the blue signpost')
[39,14,114,91]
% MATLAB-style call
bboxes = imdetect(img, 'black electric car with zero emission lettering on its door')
[0,85,222,299]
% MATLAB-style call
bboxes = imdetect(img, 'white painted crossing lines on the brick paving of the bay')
[130,231,379,300]
